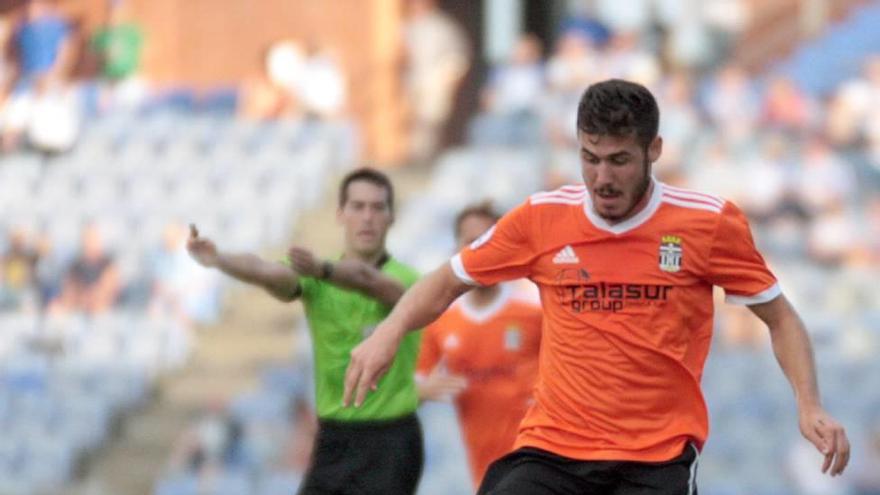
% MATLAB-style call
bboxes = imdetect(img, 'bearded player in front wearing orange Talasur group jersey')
[343,80,850,495]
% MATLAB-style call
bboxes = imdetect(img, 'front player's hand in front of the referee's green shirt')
[342,325,402,407]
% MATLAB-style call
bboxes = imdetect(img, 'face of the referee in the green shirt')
[337,180,394,255]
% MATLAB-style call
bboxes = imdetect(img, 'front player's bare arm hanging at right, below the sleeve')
[749,295,850,476]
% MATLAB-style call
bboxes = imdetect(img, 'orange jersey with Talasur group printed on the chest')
[451,181,780,462]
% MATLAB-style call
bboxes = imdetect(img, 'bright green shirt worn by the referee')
[282,258,421,421]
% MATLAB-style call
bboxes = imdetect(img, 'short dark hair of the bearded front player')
[577,79,660,149]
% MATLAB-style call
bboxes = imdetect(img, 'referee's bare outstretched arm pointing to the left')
[186,225,299,302]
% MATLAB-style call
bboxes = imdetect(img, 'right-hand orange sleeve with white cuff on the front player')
[707,202,782,305]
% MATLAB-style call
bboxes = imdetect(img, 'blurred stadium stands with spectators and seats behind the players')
[0,0,880,495]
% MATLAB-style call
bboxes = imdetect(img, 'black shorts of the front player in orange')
[477,444,698,495]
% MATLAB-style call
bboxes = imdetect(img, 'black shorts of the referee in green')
[299,414,424,495]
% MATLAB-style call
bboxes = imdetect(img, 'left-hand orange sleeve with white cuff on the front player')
[450,203,534,286]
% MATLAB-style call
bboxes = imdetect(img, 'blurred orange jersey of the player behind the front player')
[416,284,541,483]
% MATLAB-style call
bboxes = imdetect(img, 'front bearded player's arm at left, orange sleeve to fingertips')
[343,203,533,407]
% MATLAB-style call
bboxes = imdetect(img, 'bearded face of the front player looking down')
[578,132,663,222]
